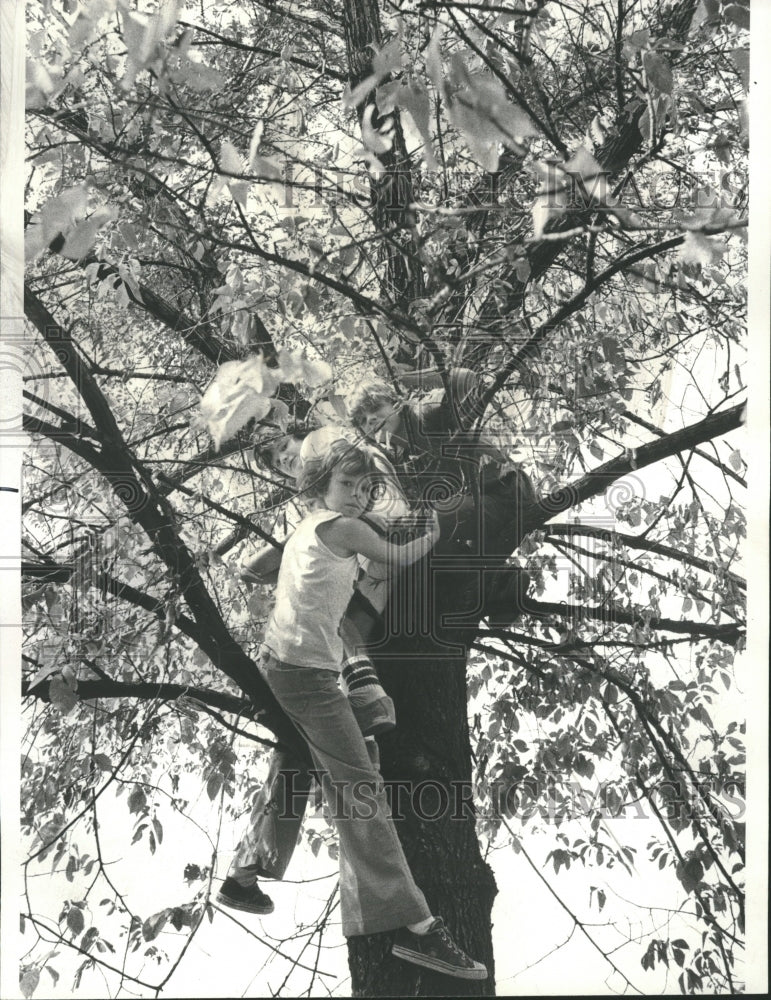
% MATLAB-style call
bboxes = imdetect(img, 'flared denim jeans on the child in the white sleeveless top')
[258,649,431,937]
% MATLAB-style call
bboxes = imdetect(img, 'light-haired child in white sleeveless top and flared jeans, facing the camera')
[255,441,487,979]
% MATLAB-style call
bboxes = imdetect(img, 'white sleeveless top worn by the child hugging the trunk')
[265,510,358,670]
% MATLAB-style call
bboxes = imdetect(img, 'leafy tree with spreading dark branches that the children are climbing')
[22,0,749,996]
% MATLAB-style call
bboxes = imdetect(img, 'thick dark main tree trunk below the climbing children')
[349,563,497,996]
